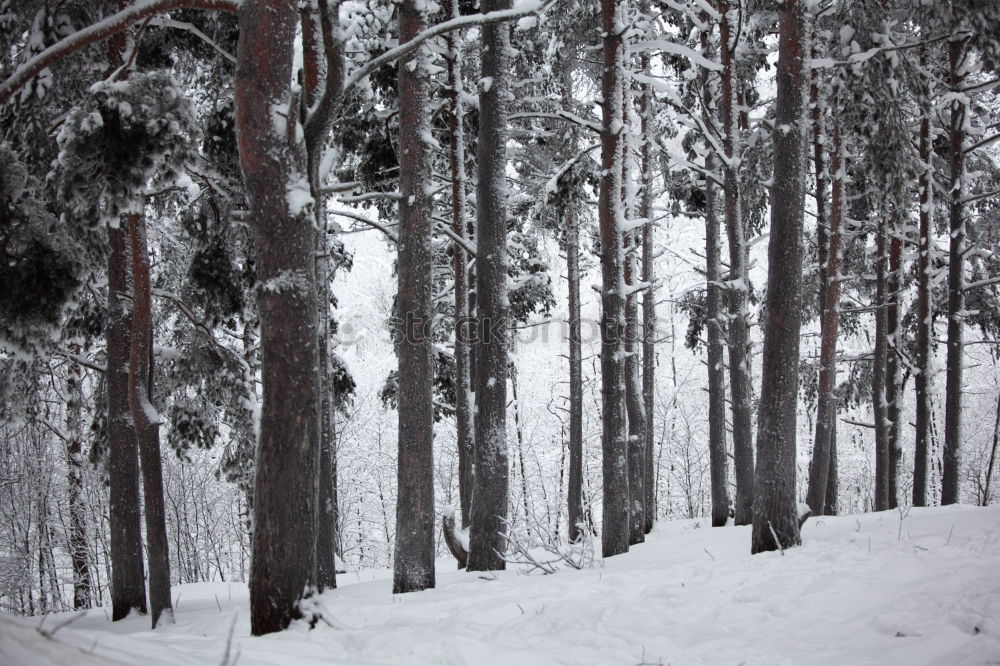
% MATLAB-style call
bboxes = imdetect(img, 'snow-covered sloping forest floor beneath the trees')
[0,506,1000,666]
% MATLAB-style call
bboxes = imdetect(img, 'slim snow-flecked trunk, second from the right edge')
[913,105,934,506]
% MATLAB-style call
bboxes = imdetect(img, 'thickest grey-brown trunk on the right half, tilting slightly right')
[751,0,805,553]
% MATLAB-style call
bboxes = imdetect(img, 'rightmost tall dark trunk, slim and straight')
[941,37,969,504]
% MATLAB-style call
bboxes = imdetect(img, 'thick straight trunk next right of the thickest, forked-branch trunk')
[392,0,435,593]
